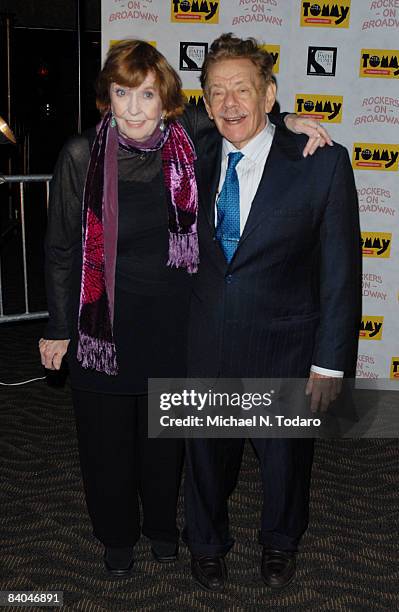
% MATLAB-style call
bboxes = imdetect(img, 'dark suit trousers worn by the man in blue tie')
[183,438,314,556]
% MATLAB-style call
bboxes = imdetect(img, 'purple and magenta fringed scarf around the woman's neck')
[77,113,199,375]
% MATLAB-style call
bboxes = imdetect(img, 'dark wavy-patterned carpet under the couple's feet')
[0,322,399,612]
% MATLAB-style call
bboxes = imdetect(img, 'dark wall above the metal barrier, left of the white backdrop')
[0,0,101,174]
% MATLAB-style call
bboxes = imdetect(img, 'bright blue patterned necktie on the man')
[216,152,243,263]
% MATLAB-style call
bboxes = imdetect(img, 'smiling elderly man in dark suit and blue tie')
[184,34,360,591]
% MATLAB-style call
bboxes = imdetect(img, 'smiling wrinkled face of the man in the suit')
[205,58,276,149]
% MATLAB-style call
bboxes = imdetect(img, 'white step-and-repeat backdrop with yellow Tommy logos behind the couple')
[102,0,399,389]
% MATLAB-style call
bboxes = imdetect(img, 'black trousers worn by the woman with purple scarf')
[73,389,184,546]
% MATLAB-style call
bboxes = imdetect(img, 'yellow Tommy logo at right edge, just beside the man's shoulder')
[352,142,399,172]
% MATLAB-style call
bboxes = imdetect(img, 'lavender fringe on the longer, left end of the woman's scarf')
[77,331,118,376]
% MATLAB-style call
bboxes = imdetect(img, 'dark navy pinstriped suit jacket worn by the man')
[189,120,361,377]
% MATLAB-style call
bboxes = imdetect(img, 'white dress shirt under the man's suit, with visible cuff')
[215,121,344,378]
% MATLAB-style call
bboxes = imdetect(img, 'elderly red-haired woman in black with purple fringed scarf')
[39,40,332,576]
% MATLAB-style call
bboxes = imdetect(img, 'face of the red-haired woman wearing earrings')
[109,72,163,142]
